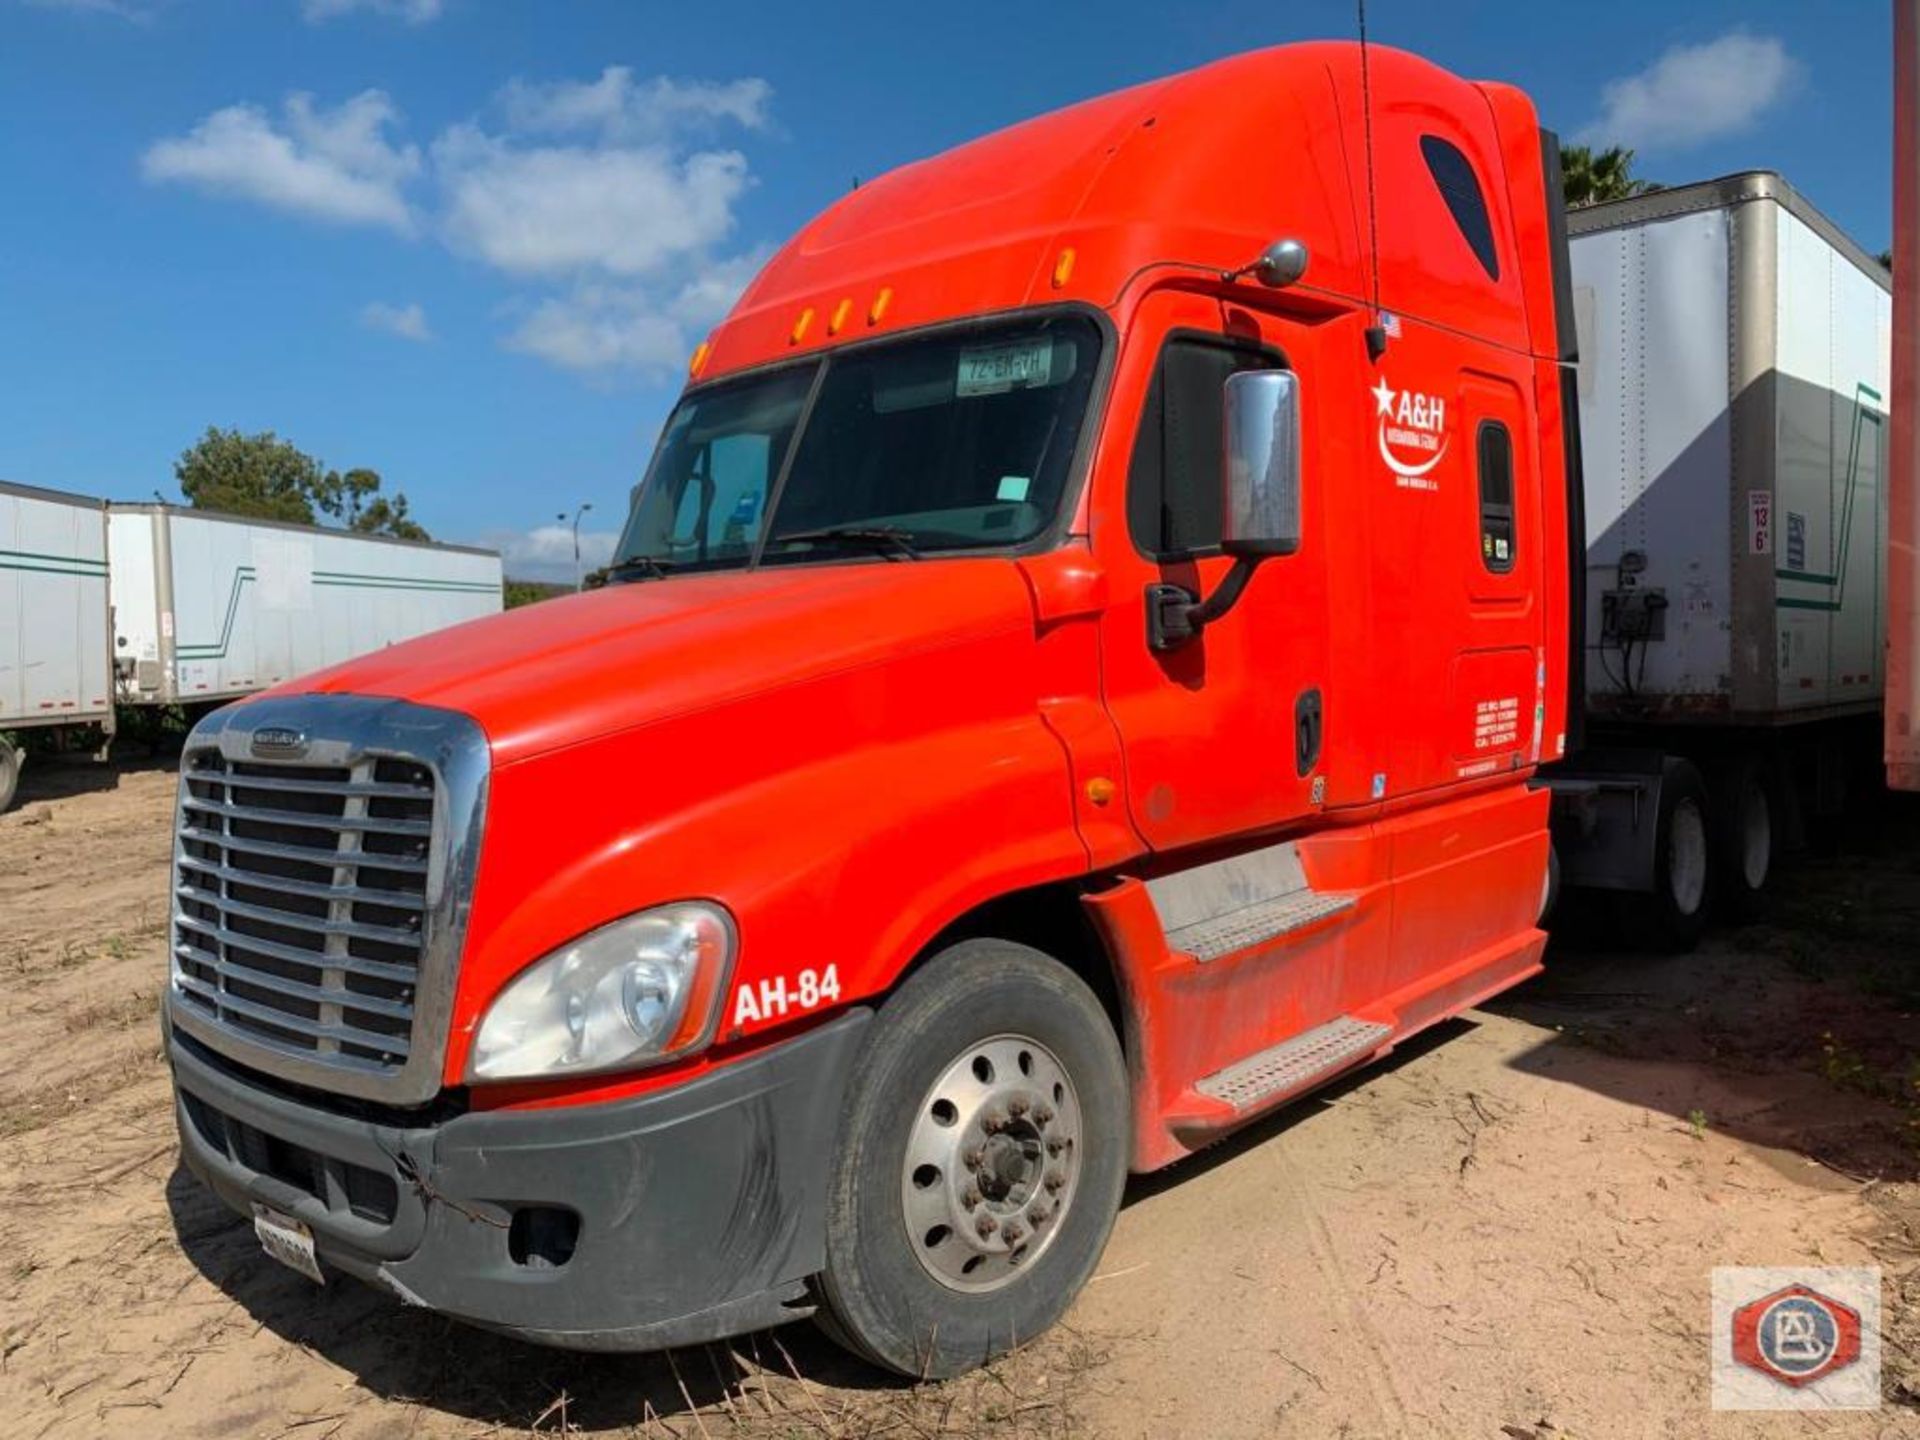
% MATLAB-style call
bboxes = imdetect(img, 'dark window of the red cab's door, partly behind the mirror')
[1127,336,1277,561]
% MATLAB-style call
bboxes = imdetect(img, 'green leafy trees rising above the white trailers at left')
[173,426,430,540]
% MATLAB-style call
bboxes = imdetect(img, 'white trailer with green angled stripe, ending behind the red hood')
[108,503,501,705]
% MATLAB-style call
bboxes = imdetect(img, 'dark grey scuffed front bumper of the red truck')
[167,1010,872,1350]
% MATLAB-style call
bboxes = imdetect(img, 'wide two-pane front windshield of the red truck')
[612,315,1100,580]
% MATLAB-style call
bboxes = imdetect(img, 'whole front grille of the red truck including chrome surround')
[167,695,492,1104]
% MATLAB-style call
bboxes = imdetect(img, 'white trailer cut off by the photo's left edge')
[0,482,113,810]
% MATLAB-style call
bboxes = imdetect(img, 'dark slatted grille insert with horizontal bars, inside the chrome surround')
[173,751,434,1069]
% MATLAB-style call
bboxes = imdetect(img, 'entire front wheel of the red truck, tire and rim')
[814,939,1129,1379]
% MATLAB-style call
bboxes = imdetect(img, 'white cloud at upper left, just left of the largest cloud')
[140,90,420,234]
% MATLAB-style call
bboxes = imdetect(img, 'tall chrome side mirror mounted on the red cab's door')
[1221,371,1300,561]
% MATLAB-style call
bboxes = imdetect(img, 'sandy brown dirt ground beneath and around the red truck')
[0,764,1920,1440]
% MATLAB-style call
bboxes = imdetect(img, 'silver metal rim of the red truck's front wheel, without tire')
[900,1035,1081,1294]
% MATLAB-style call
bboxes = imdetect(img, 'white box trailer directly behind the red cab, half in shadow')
[1553,173,1891,943]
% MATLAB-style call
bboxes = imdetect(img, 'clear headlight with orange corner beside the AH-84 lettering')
[467,900,733,1081]
